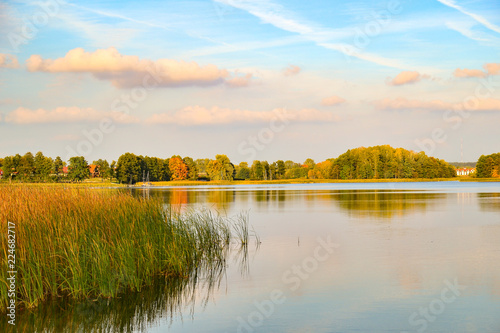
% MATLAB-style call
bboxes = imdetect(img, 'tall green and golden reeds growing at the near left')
[0,185,248,312]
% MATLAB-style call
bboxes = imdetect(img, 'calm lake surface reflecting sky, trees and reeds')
[9,182,500,332]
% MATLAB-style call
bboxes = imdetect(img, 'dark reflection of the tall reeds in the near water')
[0,266,224,332]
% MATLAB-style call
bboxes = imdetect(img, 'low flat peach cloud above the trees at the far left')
[5,107,139,124]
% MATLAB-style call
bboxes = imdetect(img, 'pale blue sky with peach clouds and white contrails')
[0,0,500,163]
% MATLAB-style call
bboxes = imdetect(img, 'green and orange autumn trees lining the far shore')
[0,145,460,184]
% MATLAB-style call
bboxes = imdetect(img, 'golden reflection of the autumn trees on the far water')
[133,188,446,218]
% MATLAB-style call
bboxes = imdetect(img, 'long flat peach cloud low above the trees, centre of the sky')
[146,105,339,126]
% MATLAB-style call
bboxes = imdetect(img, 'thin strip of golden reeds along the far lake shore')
[0,177,500,188]
